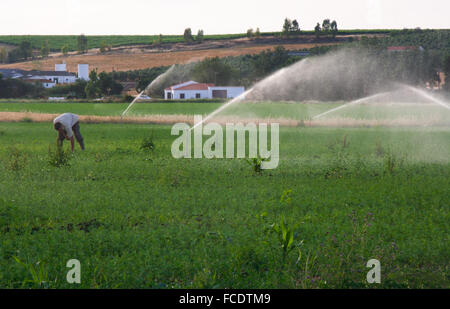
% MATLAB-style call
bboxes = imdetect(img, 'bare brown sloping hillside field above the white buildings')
[0,35,358,72]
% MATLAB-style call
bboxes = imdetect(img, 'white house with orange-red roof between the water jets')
[164,80,245,100]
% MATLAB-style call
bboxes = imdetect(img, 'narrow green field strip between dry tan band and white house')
[0,100,450,124]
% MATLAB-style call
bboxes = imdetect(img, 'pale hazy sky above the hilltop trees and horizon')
[0,0,450,35]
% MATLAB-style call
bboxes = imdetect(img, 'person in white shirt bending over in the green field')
[53,113,84,152]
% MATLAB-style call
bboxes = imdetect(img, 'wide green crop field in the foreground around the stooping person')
[0,121,450,288]
